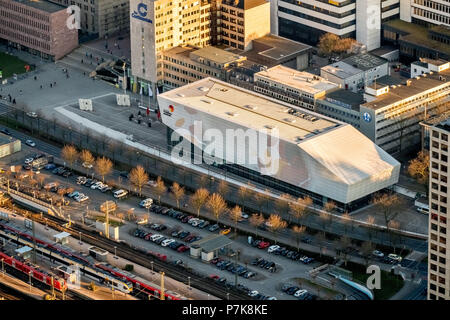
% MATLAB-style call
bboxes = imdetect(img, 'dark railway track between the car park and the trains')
[27,214,251,300]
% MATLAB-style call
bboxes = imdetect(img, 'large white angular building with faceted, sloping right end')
[158,78,400,211]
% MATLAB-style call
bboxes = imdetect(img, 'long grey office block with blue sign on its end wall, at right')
[359,69,450,153]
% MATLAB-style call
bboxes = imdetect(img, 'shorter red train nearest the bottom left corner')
[0,251,67,291]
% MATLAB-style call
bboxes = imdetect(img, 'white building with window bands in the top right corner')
[400,0,450,27]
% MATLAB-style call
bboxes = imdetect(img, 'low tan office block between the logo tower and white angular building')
[163,46,247,90]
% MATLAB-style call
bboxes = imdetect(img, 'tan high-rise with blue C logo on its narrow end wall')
[130,0,270,97]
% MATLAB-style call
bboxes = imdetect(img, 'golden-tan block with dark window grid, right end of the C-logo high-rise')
[220,0,270,50]
